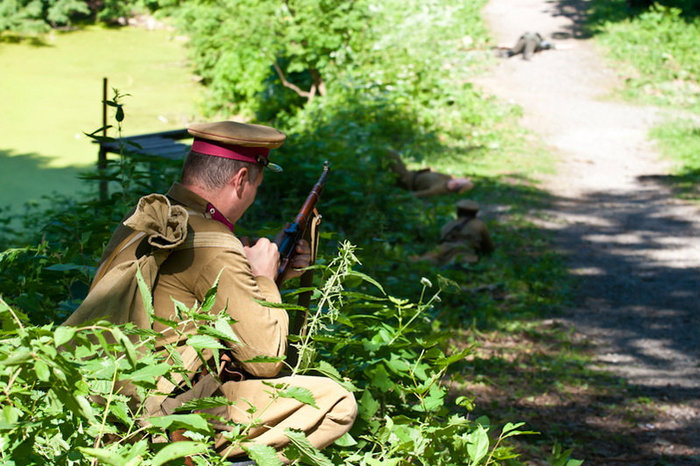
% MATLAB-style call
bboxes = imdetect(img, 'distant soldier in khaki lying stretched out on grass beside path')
[387,149,474,197]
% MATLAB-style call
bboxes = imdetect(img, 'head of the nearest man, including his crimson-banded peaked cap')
[182,121,285,222]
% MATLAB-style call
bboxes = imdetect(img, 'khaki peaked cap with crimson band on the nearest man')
[187,121,286,171]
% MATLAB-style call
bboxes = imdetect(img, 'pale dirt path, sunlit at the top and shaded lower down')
[476,0,700,464]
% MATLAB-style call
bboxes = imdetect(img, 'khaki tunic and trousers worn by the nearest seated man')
[91,183,357,456]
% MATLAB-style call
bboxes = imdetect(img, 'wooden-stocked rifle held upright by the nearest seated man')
[277,161,330,286]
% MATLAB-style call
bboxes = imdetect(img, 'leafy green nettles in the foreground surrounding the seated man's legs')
[0,243,529,465]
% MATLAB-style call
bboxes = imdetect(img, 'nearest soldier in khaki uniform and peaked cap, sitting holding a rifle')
[67,121,357,457]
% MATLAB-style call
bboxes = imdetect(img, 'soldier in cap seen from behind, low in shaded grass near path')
[417,199,495,266]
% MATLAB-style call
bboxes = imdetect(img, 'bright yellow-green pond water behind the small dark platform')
[0,23,199,209]
